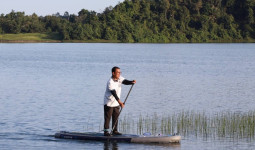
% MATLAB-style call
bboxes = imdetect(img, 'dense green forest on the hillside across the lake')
[0,0,255,43]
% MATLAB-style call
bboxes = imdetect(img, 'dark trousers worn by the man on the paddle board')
[104,105,120,131]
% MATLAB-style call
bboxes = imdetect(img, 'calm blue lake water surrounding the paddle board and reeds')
[0,44,255,150]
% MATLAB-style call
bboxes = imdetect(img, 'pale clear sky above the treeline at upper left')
[0,0,124,16]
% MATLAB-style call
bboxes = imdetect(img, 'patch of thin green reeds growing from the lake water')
[119,111,255,138]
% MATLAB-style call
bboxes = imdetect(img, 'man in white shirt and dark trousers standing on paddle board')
[104,67,136,136]
